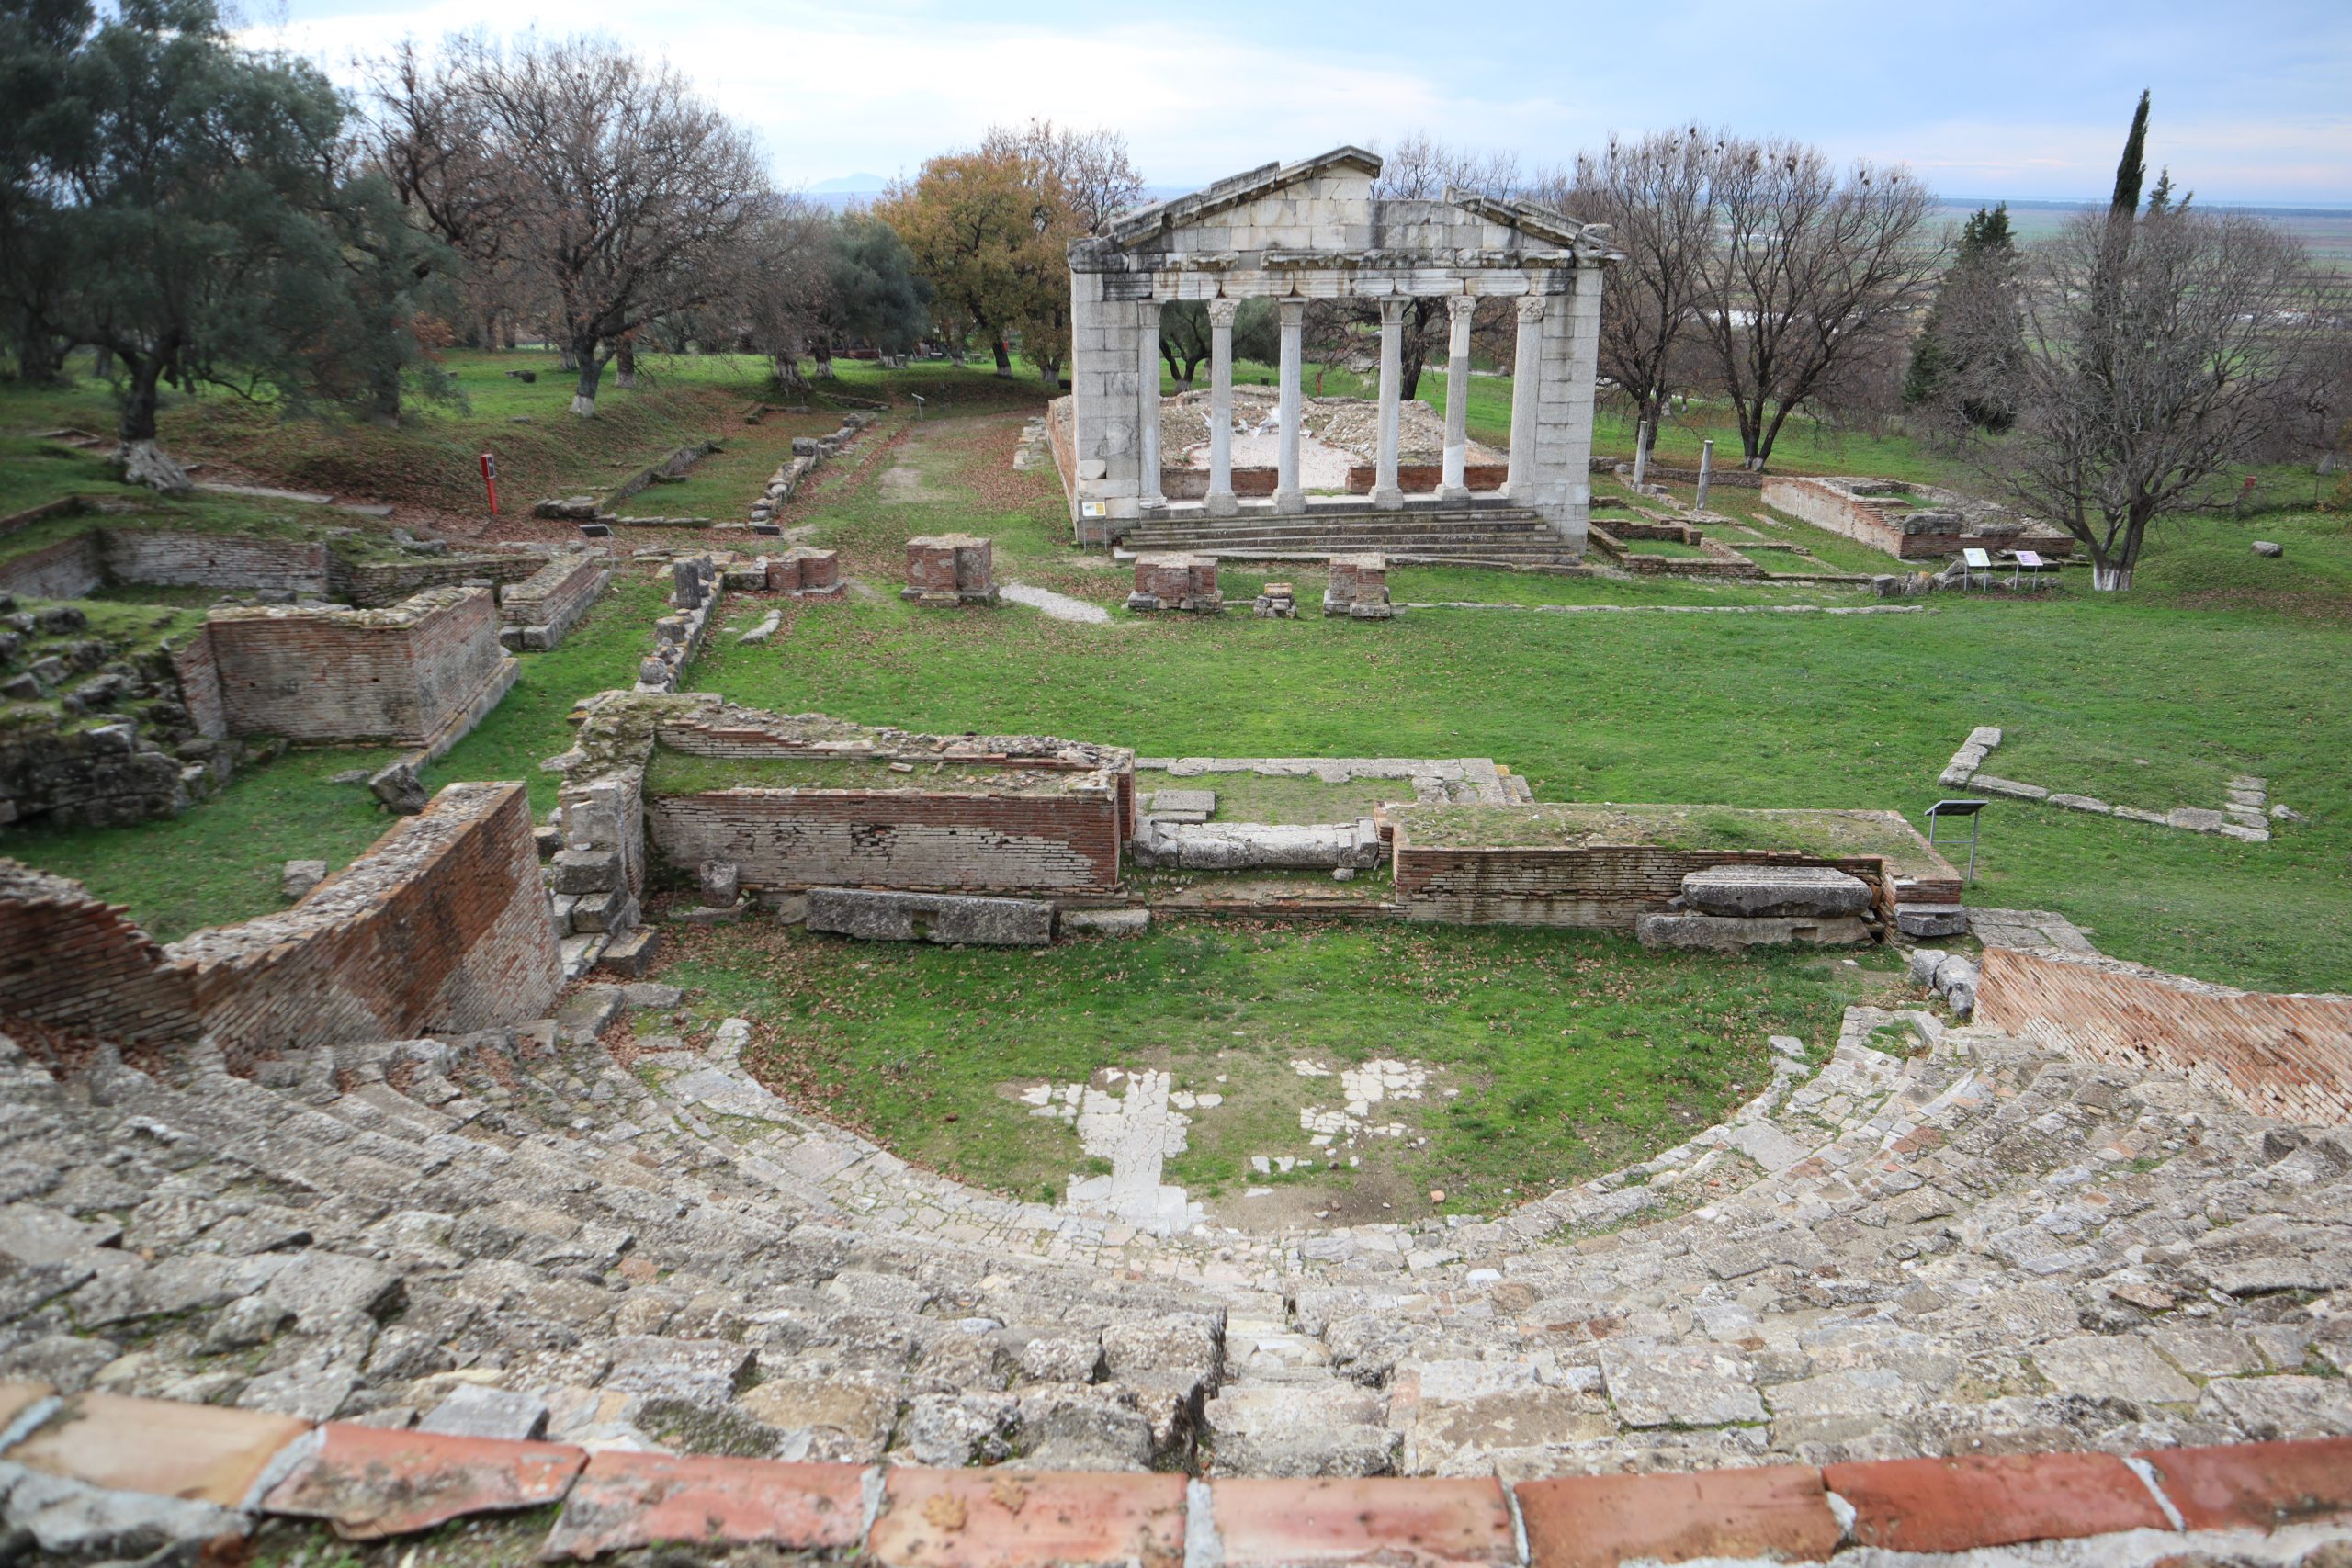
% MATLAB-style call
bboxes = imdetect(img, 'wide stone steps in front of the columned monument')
[1120,501,1578,569]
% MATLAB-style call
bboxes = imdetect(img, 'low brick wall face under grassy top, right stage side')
[1395,835,1886,931]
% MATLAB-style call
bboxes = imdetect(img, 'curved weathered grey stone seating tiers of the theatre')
[0,987,2352,1481]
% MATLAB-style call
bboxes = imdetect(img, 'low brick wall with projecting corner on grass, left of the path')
[207,588,508,745]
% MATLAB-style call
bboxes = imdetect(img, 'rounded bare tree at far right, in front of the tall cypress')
[1945,205,2347,590]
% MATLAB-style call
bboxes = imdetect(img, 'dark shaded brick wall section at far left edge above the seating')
[0,861,198,1046]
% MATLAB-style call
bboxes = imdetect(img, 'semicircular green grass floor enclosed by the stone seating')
[663,921,1894,1220]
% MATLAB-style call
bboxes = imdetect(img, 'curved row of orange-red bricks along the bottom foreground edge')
[0,1382,2352,1568]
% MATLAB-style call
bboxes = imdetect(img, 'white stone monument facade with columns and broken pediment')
[1070,146,1616,547]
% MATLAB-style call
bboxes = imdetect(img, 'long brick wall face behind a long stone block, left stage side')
[644,790,1122,891]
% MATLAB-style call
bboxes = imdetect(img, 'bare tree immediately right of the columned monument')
[1536,125,1724,430]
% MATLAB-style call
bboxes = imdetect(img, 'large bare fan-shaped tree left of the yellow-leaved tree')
[475,38,767,416]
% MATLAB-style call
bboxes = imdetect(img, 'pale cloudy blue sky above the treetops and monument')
[244,0,2352,202]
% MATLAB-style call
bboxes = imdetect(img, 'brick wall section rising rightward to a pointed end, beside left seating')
[164,783,560,1060]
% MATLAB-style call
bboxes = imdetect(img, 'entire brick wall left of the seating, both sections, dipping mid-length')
[0,783,558,1060]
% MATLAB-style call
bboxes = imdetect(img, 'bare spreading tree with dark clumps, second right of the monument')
[1698,139,1943,468]
